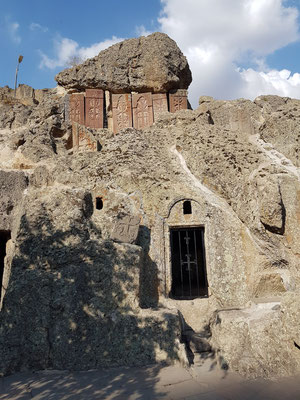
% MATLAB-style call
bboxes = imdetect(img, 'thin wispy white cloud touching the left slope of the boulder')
[40,36,124,69]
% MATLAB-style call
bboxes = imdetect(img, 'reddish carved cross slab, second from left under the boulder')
[85,89,104,129]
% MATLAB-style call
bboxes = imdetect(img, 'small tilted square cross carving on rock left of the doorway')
[111,215,140,243]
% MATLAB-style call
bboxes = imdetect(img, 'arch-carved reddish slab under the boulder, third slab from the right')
[132,93,153,129]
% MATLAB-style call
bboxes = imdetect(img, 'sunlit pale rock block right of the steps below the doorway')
[212,293,300,378]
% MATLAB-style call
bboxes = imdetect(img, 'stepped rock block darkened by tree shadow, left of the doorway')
[0,187,179,374]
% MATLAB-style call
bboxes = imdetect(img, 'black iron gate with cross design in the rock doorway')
[170,228,208,299]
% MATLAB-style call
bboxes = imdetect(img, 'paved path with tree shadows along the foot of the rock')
[0,360,300,400]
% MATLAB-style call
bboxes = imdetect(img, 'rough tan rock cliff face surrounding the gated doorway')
[0,55,300,377]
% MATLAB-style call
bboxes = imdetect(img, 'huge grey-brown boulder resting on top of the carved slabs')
[55,32,192,93]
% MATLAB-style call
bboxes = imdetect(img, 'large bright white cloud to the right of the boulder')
[159,0,300,107]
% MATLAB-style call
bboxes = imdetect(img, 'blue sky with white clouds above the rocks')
[0,0,300,107]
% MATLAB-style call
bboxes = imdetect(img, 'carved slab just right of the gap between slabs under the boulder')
[112,93,132,133]
